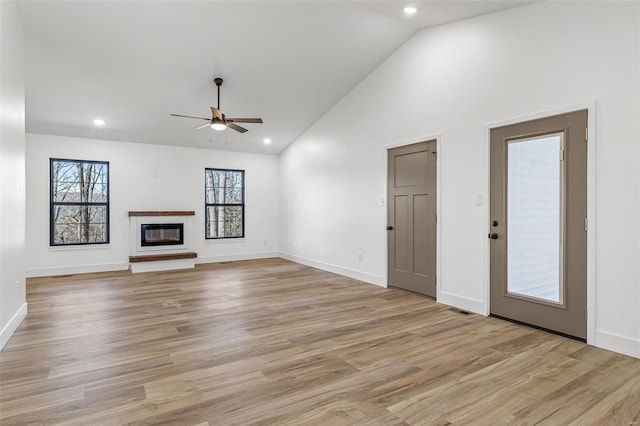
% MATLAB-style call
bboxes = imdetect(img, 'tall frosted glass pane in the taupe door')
[507,133,564,304]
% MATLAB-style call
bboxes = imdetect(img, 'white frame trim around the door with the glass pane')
[483,100,596,345]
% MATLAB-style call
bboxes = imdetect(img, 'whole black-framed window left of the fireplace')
[49,158,109,246]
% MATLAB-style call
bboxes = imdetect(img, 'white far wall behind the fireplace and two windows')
[27,133,279,276]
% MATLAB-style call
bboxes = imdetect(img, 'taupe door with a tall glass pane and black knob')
[489,110,587,339]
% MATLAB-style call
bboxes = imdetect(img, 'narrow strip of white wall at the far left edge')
[0,1,27,349]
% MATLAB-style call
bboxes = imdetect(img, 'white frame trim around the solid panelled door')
[379,133,442,300]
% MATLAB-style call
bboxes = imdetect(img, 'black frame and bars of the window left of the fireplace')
[49,158,111,247]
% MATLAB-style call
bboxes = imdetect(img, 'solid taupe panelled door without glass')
[387,140,436,297]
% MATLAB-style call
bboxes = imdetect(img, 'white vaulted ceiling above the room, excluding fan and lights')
[18,0,531,154]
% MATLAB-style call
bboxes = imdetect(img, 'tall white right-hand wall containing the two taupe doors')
[280,2,640,356]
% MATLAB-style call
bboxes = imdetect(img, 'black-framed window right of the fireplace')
[204,169,244,239]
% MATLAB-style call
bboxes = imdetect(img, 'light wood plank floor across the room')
[0,259,640,426]
